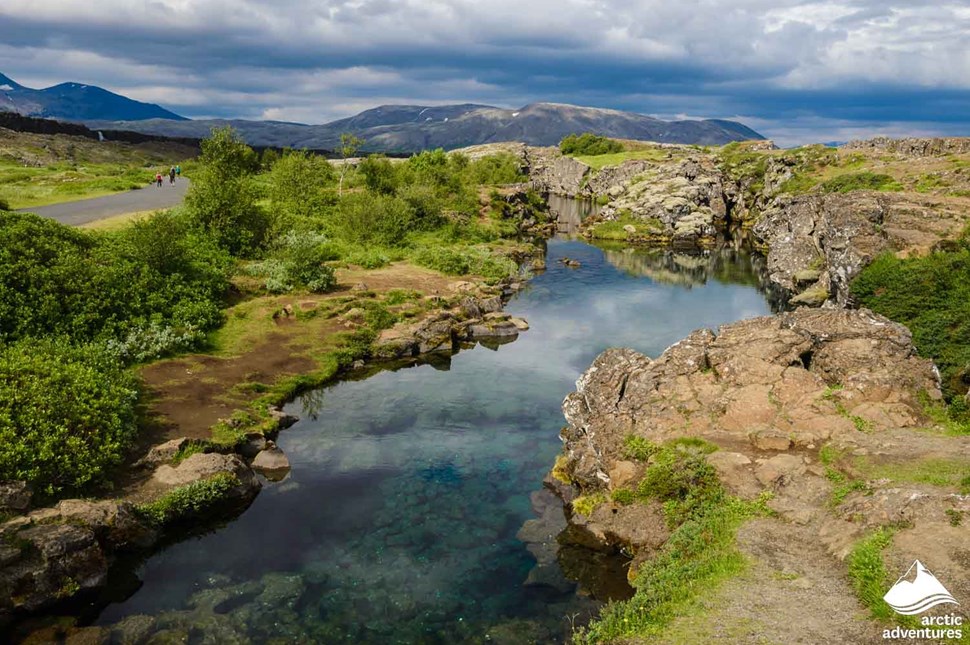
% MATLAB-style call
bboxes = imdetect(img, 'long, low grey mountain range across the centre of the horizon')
[87,103,764,152]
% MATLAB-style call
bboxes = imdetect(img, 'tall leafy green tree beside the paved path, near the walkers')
[185,126,269,255]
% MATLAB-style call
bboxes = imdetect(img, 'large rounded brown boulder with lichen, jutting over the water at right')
[562,309,939,489]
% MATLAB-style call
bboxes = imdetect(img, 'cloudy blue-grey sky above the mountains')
[0,0,970,145]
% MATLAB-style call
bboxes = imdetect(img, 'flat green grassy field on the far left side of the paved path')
[0,128,195,209]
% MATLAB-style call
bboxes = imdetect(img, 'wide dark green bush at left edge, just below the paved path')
[0,213,232,360]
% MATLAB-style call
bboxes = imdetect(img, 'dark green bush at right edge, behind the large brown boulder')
[852,247,970,404]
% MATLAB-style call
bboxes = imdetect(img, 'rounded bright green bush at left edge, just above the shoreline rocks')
[0,340,138,496]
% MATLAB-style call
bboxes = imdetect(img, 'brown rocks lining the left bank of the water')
[0,256,544,627]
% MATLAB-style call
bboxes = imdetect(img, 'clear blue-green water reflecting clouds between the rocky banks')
[91,240,769,643]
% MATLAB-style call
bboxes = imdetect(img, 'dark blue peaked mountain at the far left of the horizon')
[0,74,186,121]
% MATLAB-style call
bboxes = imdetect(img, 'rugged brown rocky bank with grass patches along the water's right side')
[537,139,970,643]
